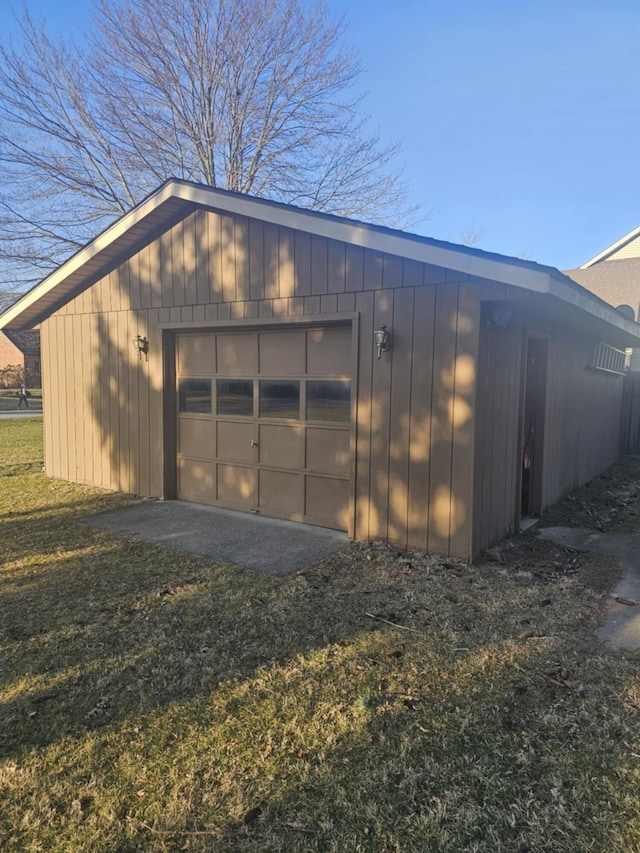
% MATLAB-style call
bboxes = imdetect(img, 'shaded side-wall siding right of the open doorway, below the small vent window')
[542,335,623,509]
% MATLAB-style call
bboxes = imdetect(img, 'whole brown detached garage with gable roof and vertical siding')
[0,180,640,559]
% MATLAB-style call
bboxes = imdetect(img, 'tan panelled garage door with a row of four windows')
[176,326,352,530]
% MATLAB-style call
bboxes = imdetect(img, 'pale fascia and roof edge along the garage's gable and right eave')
[0,178,640,340]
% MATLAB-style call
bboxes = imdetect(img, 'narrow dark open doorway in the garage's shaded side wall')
[520,335,547,517]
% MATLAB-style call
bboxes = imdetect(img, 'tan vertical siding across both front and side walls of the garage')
[43,203,632,557]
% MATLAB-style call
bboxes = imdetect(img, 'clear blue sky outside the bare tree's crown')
[0,0,640,269]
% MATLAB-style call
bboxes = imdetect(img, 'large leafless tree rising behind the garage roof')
[0,0,413,286]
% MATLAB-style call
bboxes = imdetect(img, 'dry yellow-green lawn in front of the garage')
[0,421,640,853]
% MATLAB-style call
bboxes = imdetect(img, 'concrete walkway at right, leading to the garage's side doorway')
[538,527,640,649]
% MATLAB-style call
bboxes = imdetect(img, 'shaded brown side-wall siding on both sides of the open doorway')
[473,312,623,554]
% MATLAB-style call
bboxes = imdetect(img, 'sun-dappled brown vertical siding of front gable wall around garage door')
[42,210,479,558]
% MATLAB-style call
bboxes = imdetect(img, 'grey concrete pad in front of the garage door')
[83,501,349,577]
